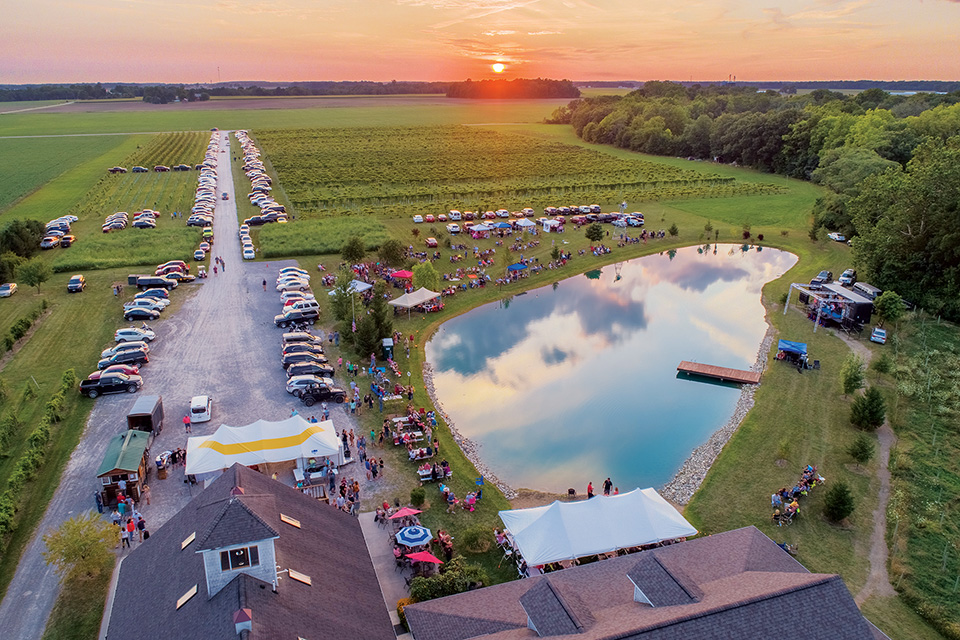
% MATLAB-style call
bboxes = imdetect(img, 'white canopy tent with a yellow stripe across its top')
[186,415,344,475]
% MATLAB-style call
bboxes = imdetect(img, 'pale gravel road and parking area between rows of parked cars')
[0,132,353,640]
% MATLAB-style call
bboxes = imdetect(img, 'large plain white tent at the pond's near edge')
[500,489,697,566]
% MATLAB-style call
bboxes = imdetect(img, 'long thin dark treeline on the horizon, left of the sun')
[0,81,450,103]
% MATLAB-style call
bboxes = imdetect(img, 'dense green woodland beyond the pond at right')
[548,82,960,320]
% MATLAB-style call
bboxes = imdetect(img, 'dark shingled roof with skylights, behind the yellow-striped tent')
[107,465,395,640]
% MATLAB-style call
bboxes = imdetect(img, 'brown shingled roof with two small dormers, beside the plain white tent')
[404,527,884,640]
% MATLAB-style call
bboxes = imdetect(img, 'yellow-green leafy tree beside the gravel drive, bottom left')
[43,512,117,579]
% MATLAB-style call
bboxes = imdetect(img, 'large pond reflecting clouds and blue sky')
[426,245,797,493]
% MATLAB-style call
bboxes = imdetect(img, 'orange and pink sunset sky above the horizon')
[0,0,960,83]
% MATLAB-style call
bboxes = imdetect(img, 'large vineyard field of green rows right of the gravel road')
[258,126,780,217]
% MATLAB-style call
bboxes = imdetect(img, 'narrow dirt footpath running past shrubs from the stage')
[837,332,897,606]
